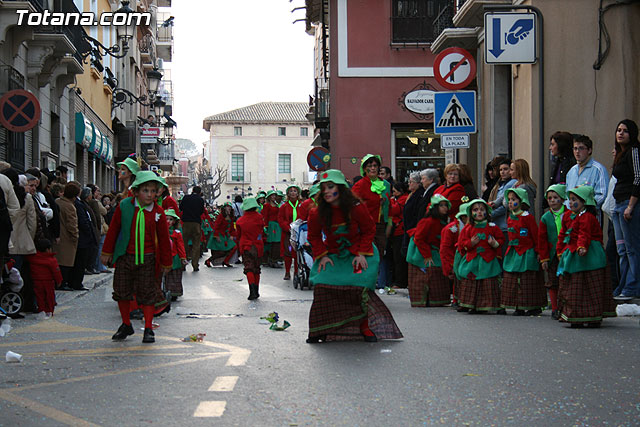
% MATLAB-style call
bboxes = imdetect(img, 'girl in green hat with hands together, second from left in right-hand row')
[456,199,504,313]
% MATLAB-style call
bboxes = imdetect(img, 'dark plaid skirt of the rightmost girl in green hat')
[558,267,616,323]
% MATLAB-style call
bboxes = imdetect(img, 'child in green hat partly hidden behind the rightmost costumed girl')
[538,184,567,320]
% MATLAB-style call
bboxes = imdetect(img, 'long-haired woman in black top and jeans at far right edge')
[613,119,640,301]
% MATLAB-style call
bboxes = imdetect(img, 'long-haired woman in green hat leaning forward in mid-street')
[307,169,402,343]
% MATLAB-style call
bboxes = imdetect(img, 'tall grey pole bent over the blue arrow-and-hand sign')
[484,5,547,215]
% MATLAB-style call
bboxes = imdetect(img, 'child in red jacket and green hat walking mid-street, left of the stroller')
[236,197,264,300]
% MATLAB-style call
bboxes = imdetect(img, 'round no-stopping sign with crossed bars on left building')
[0,89,40,132]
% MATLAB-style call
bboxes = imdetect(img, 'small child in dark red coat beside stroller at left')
[28,239,62,319]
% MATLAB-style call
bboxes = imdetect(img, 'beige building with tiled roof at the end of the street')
[203,102,315,203]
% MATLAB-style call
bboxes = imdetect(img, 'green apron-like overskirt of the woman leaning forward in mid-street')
[309,245,380,290]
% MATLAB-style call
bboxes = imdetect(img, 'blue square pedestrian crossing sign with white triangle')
[434,90,476,134]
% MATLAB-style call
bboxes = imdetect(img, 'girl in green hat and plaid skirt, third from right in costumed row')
[500,188,547,316]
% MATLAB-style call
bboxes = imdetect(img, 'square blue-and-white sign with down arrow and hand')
[484,12,536,64]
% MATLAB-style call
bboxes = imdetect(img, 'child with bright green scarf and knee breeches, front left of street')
[101,171,172,343]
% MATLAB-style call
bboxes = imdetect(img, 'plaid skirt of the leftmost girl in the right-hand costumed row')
[408,264,451,307]
